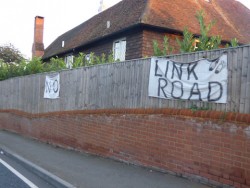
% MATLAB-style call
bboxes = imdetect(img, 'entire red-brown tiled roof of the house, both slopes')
[43,0,250,59]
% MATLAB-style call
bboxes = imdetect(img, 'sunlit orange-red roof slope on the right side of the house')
[142,0,250,43]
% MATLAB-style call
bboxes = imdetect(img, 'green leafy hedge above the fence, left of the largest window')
[0,53,115,81]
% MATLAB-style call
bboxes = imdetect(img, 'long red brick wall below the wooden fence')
[0,109,250,188]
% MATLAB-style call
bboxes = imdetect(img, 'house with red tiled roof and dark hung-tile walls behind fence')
[34,0,250,61]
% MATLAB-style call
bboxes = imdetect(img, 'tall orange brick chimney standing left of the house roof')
[32,16,44,57]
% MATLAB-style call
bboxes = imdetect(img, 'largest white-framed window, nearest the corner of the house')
[113,39,126,61]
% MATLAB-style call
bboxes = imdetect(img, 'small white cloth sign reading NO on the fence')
[44,73,60,99]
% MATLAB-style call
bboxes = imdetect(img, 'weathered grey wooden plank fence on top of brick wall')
[0,45,250,113]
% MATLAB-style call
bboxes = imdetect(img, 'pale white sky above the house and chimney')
[0,0,250,58]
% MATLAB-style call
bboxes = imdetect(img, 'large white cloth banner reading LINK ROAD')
[148,54,228,103]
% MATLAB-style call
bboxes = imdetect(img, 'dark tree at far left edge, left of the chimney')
[0,44,25,64]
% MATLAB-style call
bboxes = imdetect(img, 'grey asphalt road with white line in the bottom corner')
[0,151,53,188]
